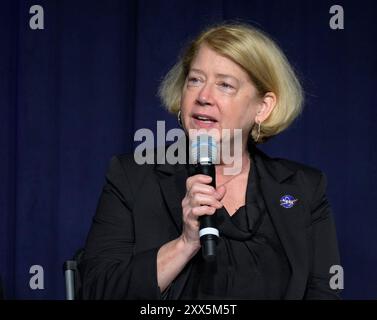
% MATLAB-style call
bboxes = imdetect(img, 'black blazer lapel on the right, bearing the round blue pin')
[254,148,309,299]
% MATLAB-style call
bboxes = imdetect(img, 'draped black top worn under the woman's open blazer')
[182,158,291,299]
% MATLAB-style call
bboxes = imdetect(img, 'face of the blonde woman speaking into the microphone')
[181,45,260,142]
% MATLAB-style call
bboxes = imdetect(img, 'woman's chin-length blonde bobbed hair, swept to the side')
[159,24,303,143]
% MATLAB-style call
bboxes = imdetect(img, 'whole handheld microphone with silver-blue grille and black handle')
[191,134,219,261]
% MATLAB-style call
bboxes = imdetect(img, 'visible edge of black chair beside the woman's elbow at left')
[63,248,85,300]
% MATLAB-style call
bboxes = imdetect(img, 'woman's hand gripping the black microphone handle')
[181,174,226,248]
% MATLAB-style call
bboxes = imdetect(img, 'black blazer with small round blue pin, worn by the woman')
[79,142,339,299]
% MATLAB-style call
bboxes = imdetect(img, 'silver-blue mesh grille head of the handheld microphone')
[191,134,217,164]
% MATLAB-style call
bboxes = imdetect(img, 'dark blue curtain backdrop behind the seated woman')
[0,0,377,299]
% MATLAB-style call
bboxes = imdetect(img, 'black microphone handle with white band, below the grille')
[196,164,219,262]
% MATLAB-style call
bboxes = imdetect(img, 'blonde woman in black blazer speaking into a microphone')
[80,24,339,299]
